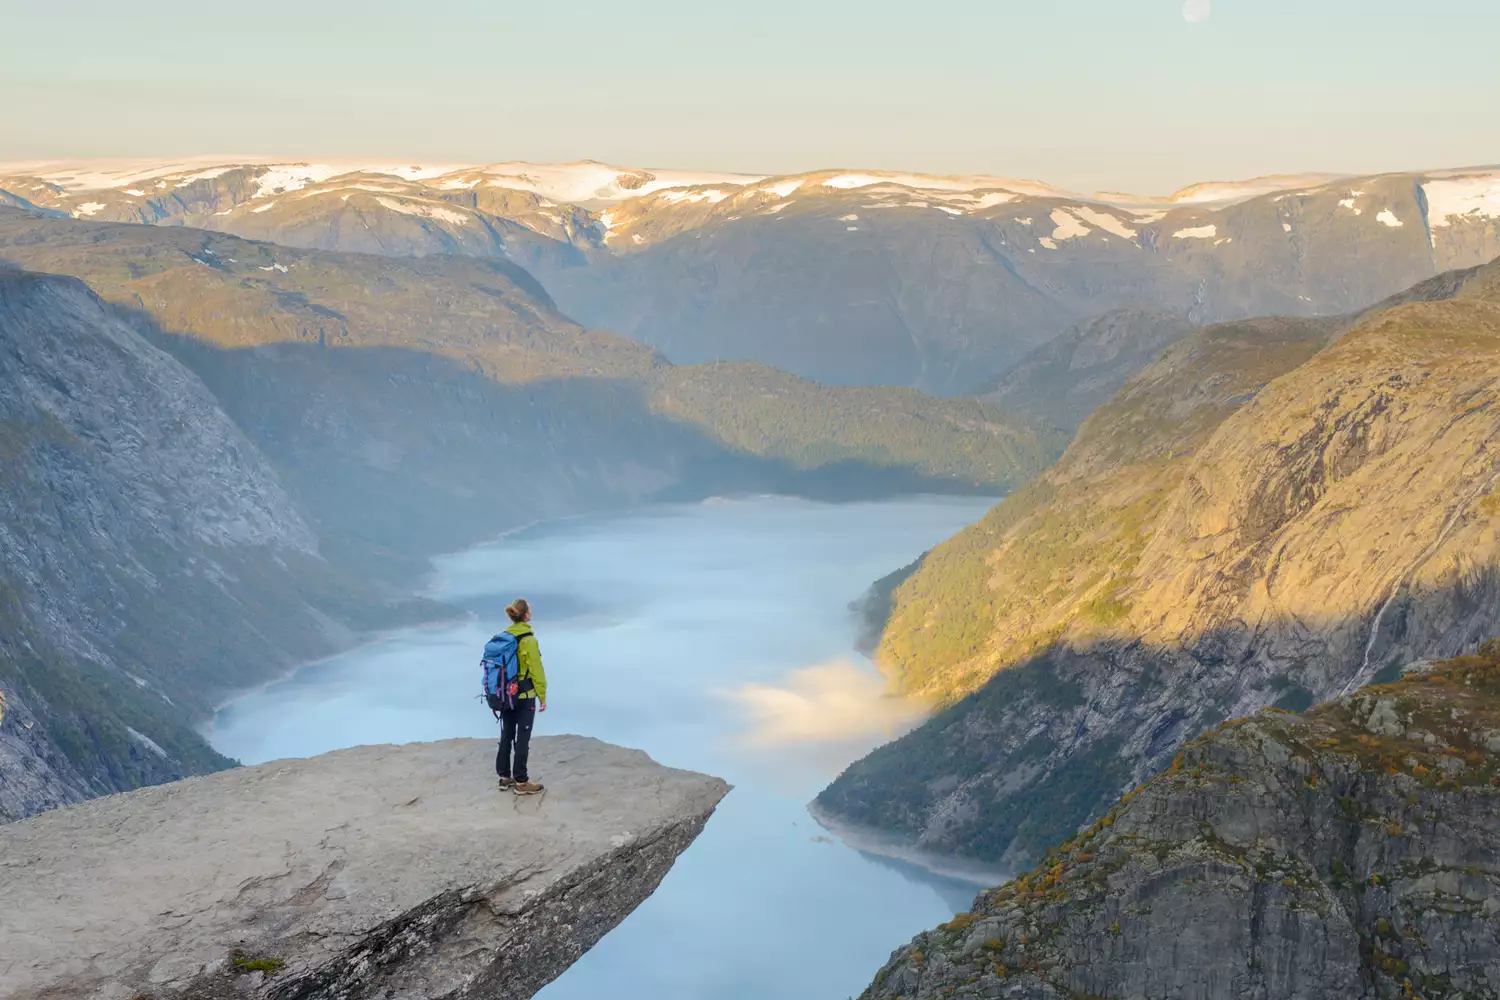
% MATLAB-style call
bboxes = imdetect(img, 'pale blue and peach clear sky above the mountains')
[0,0,1500,193]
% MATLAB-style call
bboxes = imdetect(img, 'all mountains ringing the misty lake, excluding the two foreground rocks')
[0,150,1500,893]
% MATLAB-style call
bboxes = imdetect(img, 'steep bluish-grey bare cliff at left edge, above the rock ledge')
[0,270,429,819]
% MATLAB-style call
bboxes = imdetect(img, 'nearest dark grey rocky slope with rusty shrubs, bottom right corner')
[863,642,1500,1000]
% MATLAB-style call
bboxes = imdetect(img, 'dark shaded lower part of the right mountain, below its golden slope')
[816,565,1500,870]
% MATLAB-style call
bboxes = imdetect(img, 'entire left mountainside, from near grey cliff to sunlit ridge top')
[0,210,1061,819]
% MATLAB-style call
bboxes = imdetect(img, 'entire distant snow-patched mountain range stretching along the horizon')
[11,163,1500,394]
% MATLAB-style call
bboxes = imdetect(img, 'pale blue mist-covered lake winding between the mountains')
[210,498,992,1000]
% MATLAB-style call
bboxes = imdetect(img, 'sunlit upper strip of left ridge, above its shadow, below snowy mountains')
[0,213,1064,503]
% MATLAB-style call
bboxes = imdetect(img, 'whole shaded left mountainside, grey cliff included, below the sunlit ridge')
[0,264,1020,819]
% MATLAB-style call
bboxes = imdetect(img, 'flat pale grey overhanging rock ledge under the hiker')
[0,736,729,1000]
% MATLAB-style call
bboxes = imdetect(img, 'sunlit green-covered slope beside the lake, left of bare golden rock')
[878,319,1335,700]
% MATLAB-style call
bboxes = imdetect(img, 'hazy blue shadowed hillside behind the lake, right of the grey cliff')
[125,310,1001,582]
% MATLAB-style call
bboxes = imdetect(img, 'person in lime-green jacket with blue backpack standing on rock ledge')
[483,597,548,795]
